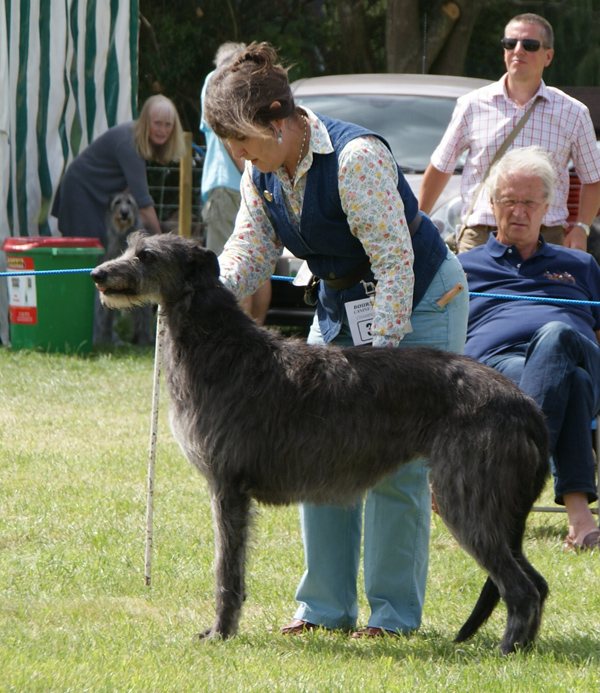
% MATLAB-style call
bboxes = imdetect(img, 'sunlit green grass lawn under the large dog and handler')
[0,347,600,693]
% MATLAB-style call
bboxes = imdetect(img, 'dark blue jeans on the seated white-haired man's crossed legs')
[485,321,600,505]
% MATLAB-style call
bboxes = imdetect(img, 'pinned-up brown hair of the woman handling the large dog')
[204,43,296,139]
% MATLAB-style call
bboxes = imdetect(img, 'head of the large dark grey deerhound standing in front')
[91,231,221,308]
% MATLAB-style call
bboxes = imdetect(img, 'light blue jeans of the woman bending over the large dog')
[295,253,469,633]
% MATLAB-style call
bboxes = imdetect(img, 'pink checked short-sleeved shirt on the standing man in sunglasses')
[431,75,600,226]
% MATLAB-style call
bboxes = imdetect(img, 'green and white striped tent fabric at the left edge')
[0,0,139,238]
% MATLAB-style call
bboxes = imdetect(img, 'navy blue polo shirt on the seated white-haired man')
[457,233,600,361]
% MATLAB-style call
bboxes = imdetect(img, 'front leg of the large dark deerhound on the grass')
[201,485,252,638]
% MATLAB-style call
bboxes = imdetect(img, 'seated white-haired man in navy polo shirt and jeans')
[458,147,600,549]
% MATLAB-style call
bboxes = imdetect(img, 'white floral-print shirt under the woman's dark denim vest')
[219,109,414,346]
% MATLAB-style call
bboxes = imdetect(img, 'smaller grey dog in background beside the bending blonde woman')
[94,190,154,346]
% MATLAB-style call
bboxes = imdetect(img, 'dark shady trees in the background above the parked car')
[139,0,600,138]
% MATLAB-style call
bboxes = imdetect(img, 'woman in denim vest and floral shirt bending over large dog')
[204,43,468,637]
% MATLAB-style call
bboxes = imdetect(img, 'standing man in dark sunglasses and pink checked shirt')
[419,14,600,252]
